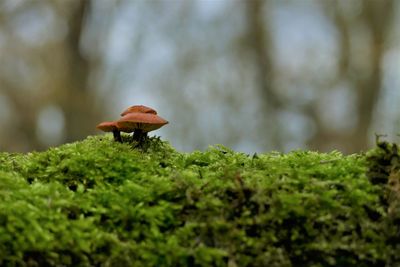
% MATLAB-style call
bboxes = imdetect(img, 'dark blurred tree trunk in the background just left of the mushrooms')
[57,0,102,142]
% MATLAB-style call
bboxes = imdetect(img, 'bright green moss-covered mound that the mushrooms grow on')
[0,136,399,267]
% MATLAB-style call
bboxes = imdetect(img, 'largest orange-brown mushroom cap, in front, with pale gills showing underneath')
[117,112,168,133]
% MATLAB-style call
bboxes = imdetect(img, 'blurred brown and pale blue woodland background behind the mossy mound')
[0,0,400,153]
